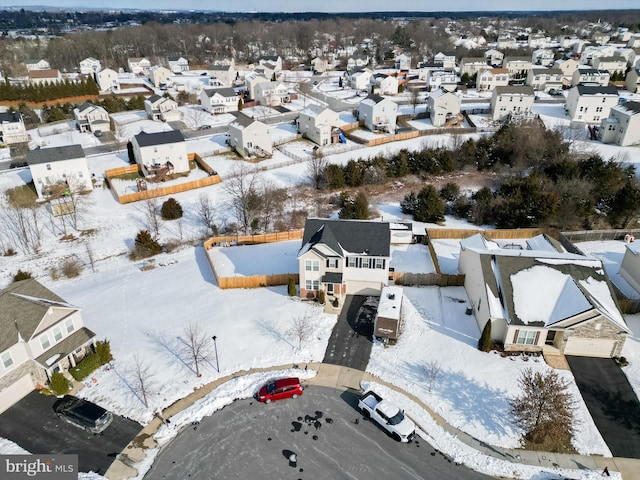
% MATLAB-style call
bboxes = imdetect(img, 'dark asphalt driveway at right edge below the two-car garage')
[567,356,640,458]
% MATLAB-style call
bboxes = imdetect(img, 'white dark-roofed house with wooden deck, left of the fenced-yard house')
[26,145,93,200]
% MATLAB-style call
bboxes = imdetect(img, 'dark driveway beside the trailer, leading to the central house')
[323,295,373,370]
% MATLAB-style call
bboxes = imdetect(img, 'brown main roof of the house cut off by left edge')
[0,279,77,352]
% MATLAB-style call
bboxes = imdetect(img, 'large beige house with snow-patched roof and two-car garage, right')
[458,234,631,358]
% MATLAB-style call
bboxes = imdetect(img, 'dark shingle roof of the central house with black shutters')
[298,218,391,257]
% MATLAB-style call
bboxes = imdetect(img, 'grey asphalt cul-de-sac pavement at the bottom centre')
[145,387,490,480]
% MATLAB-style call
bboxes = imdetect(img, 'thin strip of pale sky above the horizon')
[7,0,639,12]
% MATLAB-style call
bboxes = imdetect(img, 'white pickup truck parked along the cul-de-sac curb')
[358,390,416,442]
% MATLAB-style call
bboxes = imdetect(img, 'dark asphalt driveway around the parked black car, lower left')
[0,391,142,474]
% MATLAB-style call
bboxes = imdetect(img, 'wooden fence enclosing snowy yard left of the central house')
[204,230,303,288]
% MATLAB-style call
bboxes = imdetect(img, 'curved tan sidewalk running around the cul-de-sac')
[105,363,640,480]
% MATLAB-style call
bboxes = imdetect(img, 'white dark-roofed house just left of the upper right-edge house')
[565,85,619,125]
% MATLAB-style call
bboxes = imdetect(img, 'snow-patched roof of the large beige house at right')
[461,234,629,332]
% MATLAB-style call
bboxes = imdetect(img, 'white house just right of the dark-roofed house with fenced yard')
[229,113,273,158]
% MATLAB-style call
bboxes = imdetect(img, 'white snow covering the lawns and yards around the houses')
[0,93,640,478]
